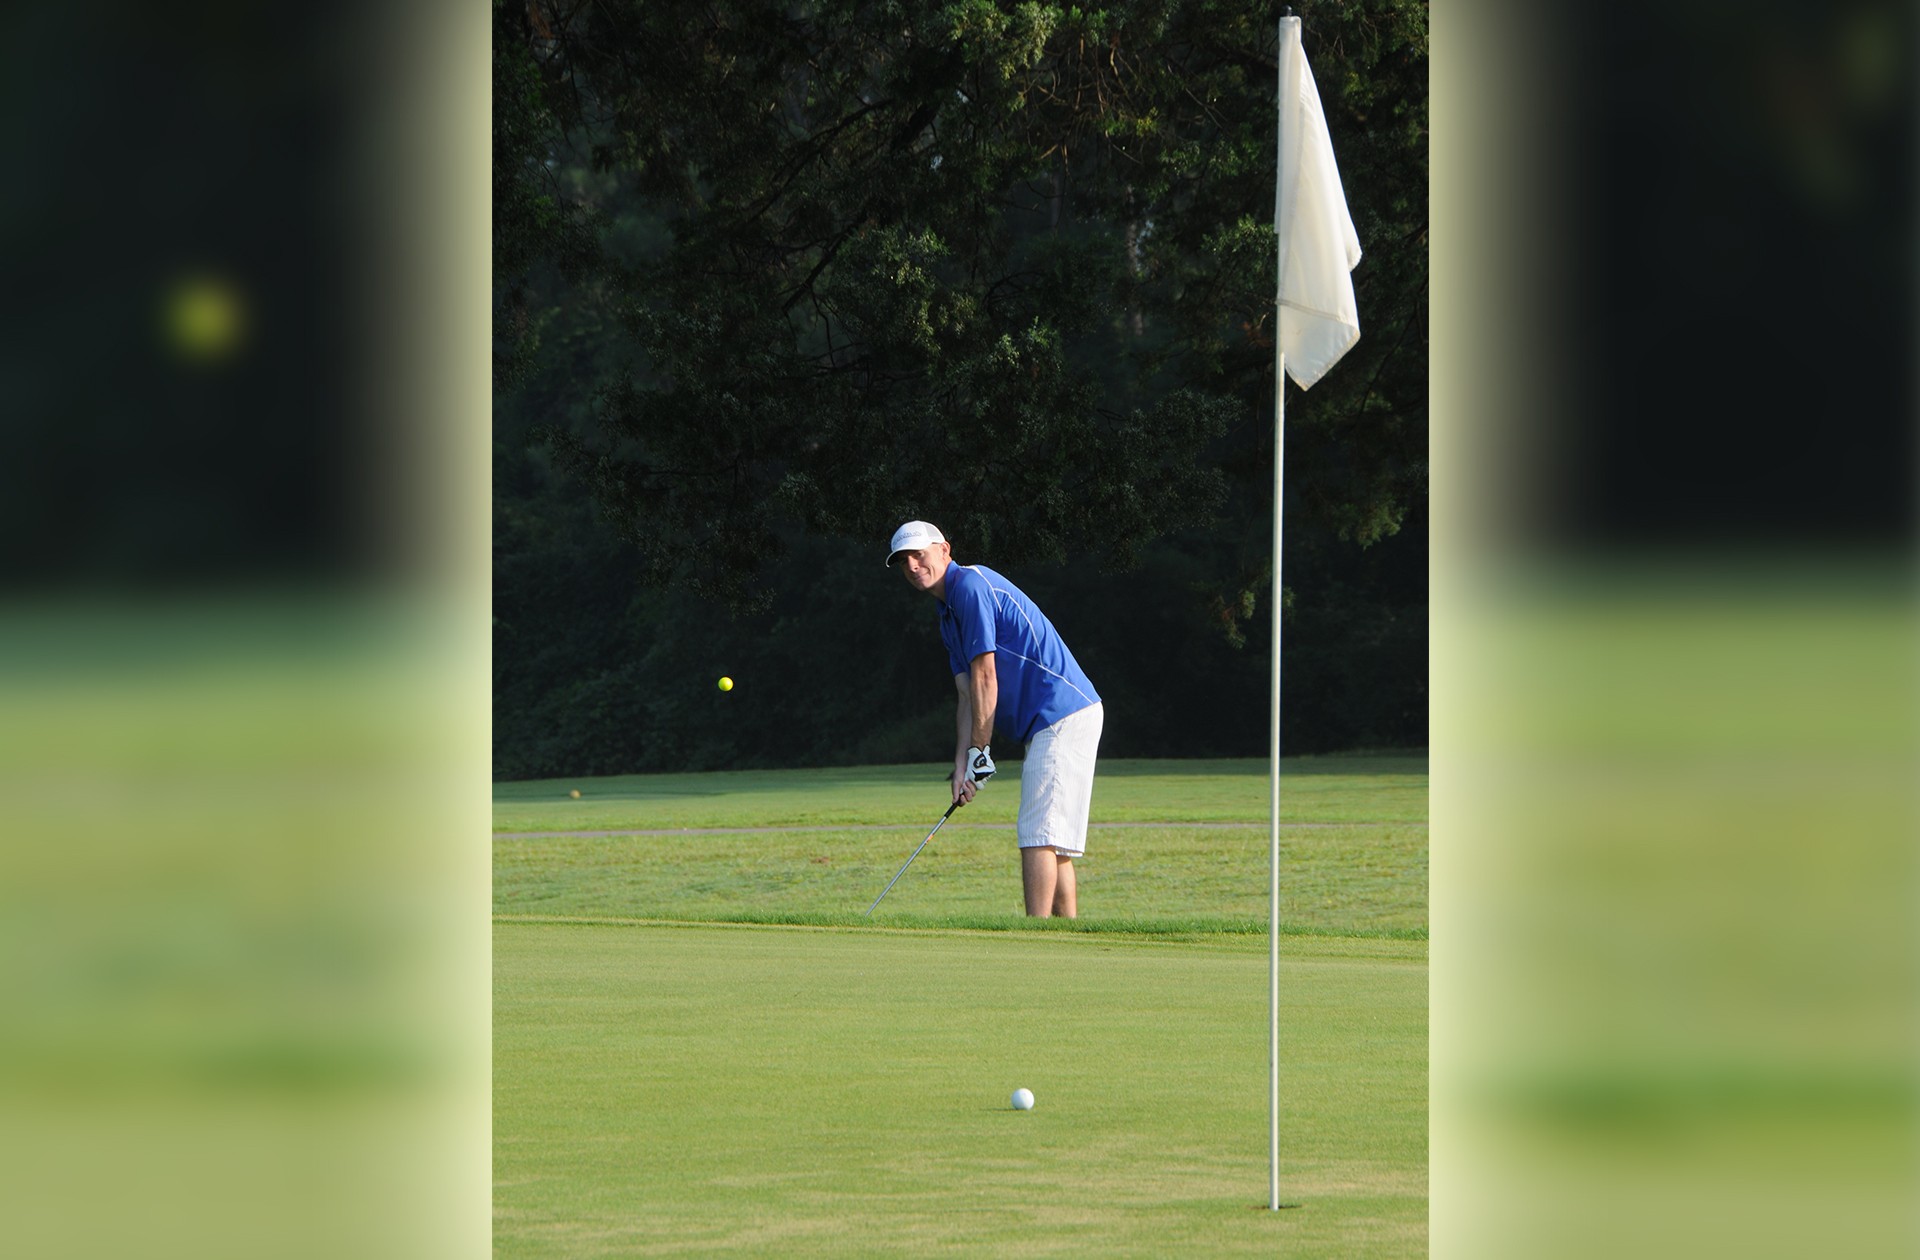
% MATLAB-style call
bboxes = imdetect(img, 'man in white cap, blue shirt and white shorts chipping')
[887,521,1104,918]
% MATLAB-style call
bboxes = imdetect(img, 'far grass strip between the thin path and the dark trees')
[493,755,1427,832]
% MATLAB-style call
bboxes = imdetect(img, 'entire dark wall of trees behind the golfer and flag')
[493,0,1427,776]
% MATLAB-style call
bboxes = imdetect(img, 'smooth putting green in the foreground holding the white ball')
[493,924,1427,1258]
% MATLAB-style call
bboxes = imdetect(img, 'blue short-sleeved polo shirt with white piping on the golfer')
[939,565,1100,743]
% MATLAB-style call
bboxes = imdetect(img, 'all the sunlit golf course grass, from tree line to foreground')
[493,755,1427,1256]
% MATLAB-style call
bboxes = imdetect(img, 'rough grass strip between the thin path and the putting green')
[493,824,1427,935]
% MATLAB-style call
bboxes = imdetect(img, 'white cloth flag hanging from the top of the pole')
[1273,17,1359,390]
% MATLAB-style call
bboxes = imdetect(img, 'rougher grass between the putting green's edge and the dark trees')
[493,757,1427,937]
